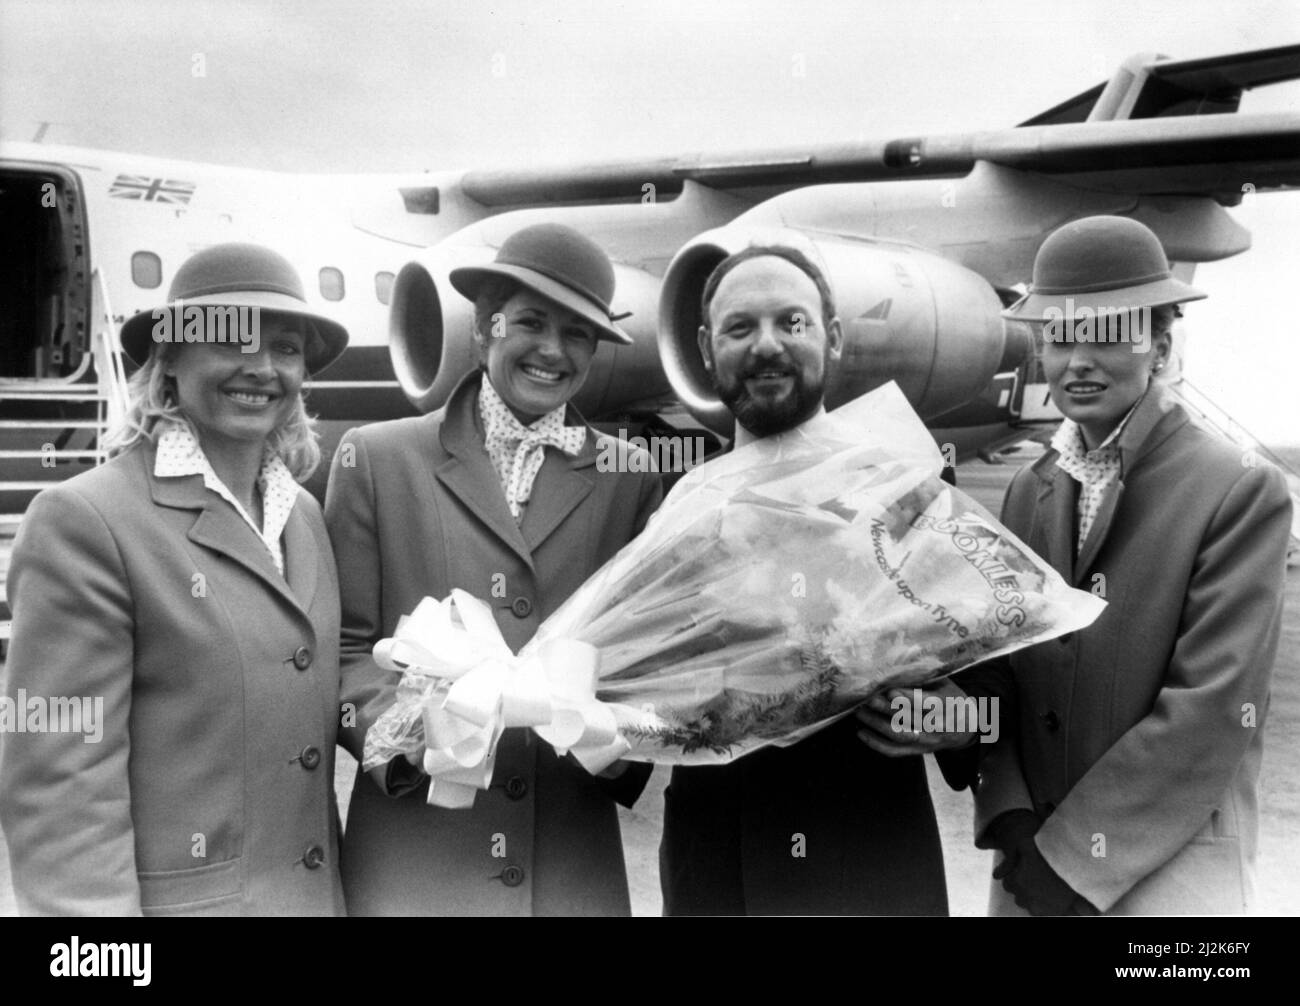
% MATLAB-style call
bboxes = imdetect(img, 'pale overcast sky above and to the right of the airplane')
[0,0,1300,443]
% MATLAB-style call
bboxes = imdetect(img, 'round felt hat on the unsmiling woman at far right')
[1002,216,1205,321]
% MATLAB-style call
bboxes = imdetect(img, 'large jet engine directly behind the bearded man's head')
[659,226,1013,434]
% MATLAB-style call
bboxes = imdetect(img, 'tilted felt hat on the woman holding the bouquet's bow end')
[450,224,632,346]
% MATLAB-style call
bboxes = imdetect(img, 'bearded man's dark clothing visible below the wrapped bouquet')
[659,444,952,915]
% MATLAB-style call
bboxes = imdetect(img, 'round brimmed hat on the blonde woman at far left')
[121,244,347,374]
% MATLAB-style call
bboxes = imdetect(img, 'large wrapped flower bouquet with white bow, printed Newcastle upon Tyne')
[365,385,1104,805]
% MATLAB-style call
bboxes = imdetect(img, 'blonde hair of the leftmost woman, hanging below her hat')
[104,342,321,482]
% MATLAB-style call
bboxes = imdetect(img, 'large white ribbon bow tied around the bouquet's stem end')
[367,590,631,808]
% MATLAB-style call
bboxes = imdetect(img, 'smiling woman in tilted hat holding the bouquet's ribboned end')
[325,225,660,915]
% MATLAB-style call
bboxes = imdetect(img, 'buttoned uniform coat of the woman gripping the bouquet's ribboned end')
[325,373,662,915]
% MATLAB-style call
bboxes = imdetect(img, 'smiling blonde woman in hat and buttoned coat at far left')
[0,244,347,915]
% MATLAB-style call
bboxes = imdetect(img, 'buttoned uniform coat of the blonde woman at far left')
[0,443,343,915]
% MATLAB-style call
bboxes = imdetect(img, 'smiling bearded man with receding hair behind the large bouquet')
[659,244,948,915]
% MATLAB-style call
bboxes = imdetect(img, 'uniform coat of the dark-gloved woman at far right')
[976,386,1291,914]
